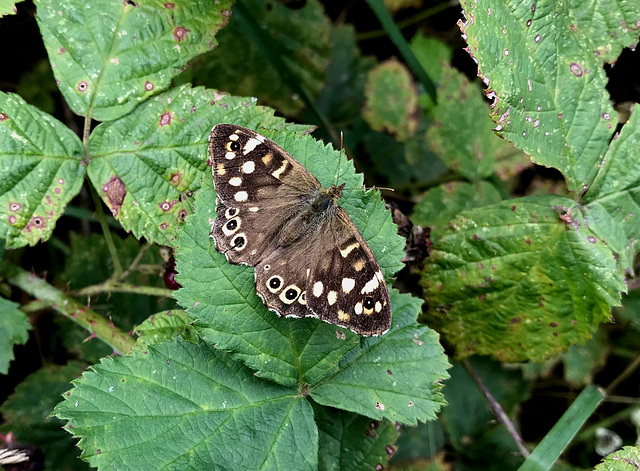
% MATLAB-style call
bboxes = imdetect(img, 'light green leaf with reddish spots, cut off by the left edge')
[0,92,85,248]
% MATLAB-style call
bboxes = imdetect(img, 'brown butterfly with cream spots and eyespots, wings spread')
[209,124,391,336]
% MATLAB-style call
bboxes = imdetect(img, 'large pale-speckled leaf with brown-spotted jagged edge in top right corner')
[461,0,640,192]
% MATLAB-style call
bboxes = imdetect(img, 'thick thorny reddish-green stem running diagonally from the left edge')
[0,261,135,354]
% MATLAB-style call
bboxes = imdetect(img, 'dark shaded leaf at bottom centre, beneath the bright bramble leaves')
[314,406,398,471]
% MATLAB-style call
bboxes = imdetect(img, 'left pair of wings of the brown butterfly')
[209,124,320,266]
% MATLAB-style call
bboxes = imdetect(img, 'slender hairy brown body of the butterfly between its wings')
[278,183,345,247]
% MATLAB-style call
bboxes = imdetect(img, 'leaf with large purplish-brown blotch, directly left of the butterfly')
[87,86,296,245]
